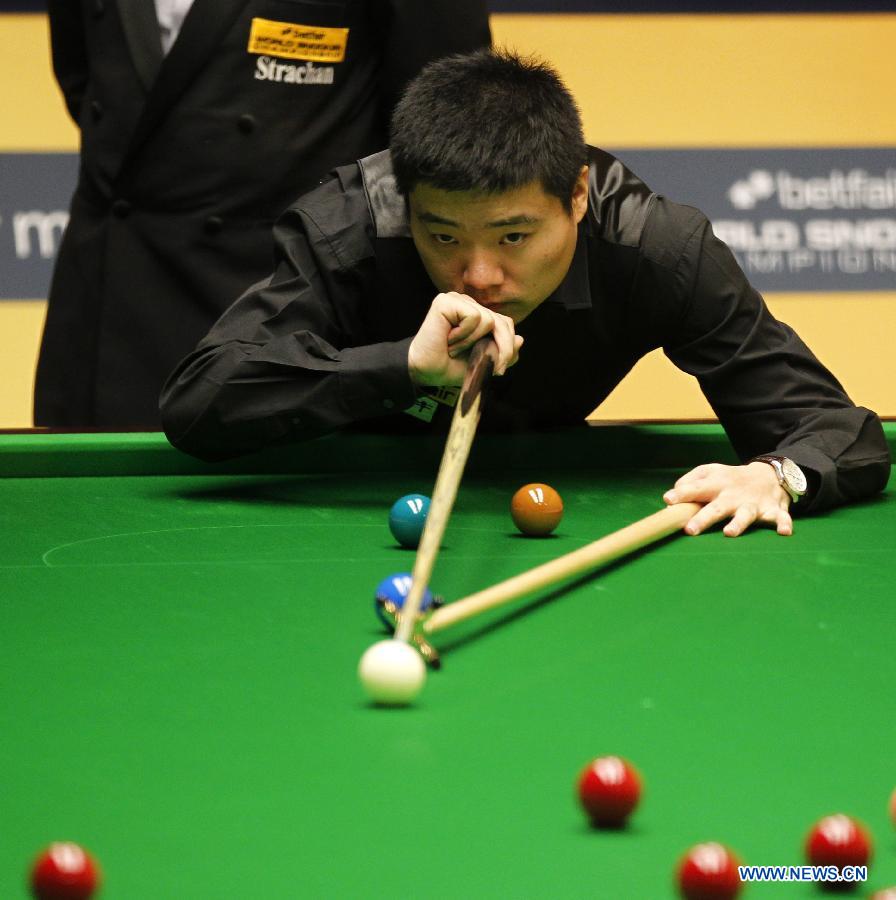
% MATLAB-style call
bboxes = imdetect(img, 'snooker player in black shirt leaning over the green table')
[161,51,889,536]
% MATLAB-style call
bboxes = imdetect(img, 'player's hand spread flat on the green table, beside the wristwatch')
[663,462,793,537]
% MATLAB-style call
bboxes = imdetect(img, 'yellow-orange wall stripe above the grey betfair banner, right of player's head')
[492,14,896,147]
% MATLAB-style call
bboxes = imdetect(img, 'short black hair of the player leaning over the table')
[390,50,587,209]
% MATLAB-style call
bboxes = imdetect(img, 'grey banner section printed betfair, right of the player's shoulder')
[611,147,896,293]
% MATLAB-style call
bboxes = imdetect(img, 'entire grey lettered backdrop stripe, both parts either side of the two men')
[0,147,896,300]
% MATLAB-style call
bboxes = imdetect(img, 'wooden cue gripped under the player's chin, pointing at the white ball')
[395,337,498,643]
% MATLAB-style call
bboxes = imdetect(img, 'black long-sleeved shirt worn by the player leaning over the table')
[161,148,889,511]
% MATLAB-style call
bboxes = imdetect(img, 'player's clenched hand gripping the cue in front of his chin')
[408,292,523,387]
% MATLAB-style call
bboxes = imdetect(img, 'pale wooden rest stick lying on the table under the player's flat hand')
[421,503,701,634]
